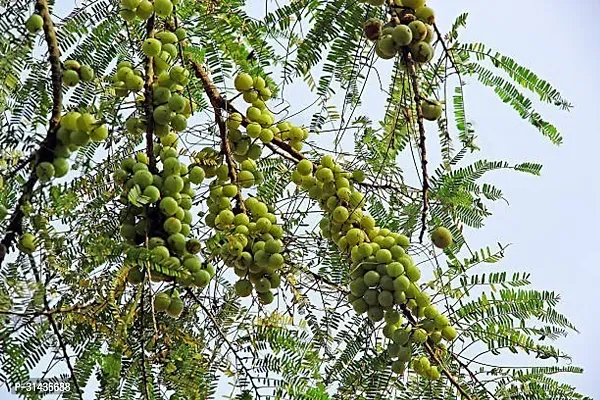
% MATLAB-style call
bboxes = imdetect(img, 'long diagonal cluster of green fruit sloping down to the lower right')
[292,156,457,379]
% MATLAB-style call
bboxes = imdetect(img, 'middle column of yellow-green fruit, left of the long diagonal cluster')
[199,73,308,304]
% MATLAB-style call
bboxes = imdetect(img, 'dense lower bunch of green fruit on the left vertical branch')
[114,148,215,304]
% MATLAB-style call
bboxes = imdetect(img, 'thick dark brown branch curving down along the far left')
[0,0,63,265]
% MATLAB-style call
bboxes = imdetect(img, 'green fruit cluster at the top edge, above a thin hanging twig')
[364,0,435,63]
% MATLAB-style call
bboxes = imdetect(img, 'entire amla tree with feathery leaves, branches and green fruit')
[0,0,582,399]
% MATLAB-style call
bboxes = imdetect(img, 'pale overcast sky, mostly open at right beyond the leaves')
[0,0,600,398]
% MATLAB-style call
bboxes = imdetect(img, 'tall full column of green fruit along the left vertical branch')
[114,5,215,317]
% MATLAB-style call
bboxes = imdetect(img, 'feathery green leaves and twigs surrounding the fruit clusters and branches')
[0,0,585,399]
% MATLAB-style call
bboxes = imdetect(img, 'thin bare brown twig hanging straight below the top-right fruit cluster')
[404,51,430,243]
